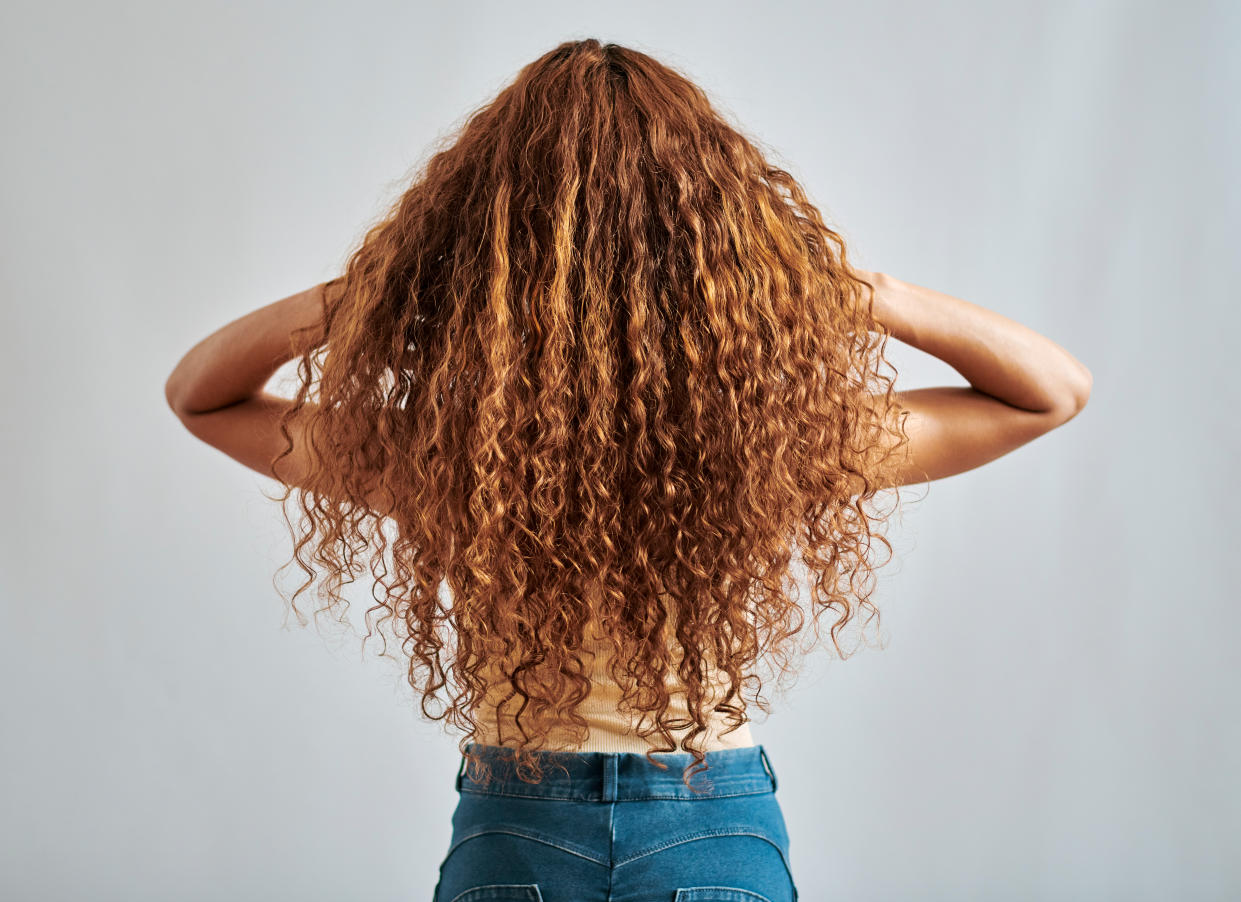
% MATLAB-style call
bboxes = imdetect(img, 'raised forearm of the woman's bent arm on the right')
[862,273,1091,411]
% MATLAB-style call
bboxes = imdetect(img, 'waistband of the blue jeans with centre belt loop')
[457,742,777,802]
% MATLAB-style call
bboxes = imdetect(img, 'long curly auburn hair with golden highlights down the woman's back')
[272,40,908,783]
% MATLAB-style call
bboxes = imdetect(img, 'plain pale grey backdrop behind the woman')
[0,0,1241,902]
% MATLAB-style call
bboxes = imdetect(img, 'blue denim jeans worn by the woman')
[433,744,797,902]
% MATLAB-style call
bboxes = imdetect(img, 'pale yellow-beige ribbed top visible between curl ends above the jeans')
[470,595,755,753]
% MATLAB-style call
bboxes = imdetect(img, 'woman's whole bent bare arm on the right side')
[854,270,1092,494]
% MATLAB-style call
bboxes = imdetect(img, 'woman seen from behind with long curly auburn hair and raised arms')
[166,40,1091,902]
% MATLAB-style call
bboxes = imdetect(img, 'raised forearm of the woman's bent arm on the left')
[164,283,323,416]
